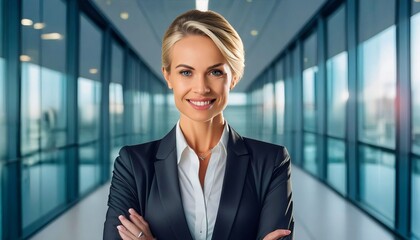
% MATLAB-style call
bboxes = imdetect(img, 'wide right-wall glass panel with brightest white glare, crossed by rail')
[358,0,397,226]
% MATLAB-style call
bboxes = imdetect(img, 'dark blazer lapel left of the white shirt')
[155,128,192,240]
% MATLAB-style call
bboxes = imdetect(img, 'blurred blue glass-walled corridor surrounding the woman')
[0,0,420,240]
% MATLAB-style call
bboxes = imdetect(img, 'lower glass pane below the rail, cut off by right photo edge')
[411,158,420,238]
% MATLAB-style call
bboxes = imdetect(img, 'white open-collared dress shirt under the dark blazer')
[176,121,229,240]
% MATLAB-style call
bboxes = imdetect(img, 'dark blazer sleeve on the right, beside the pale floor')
[254,147,294,240]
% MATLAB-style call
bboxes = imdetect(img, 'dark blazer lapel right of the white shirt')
[212,126,249,240]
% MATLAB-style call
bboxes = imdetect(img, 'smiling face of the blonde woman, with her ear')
[163,35,234,122]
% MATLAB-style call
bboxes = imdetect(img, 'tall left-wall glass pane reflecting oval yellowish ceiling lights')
[20,0,67,155]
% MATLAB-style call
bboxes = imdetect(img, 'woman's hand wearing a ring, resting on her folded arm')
[117,208,155,240]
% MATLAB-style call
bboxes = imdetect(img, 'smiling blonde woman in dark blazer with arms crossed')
[104,10,294,240]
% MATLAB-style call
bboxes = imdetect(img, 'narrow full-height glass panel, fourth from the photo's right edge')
[302,33,318,175]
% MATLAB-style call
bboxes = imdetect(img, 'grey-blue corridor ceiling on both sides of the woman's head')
[90,0,326,92]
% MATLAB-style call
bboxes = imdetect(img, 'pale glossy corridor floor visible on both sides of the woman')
[31,167,394,240]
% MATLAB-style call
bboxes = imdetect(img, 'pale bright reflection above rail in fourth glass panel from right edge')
[303,66,318,131]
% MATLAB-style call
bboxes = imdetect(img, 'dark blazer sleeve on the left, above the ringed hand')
[103,147,139,240]
